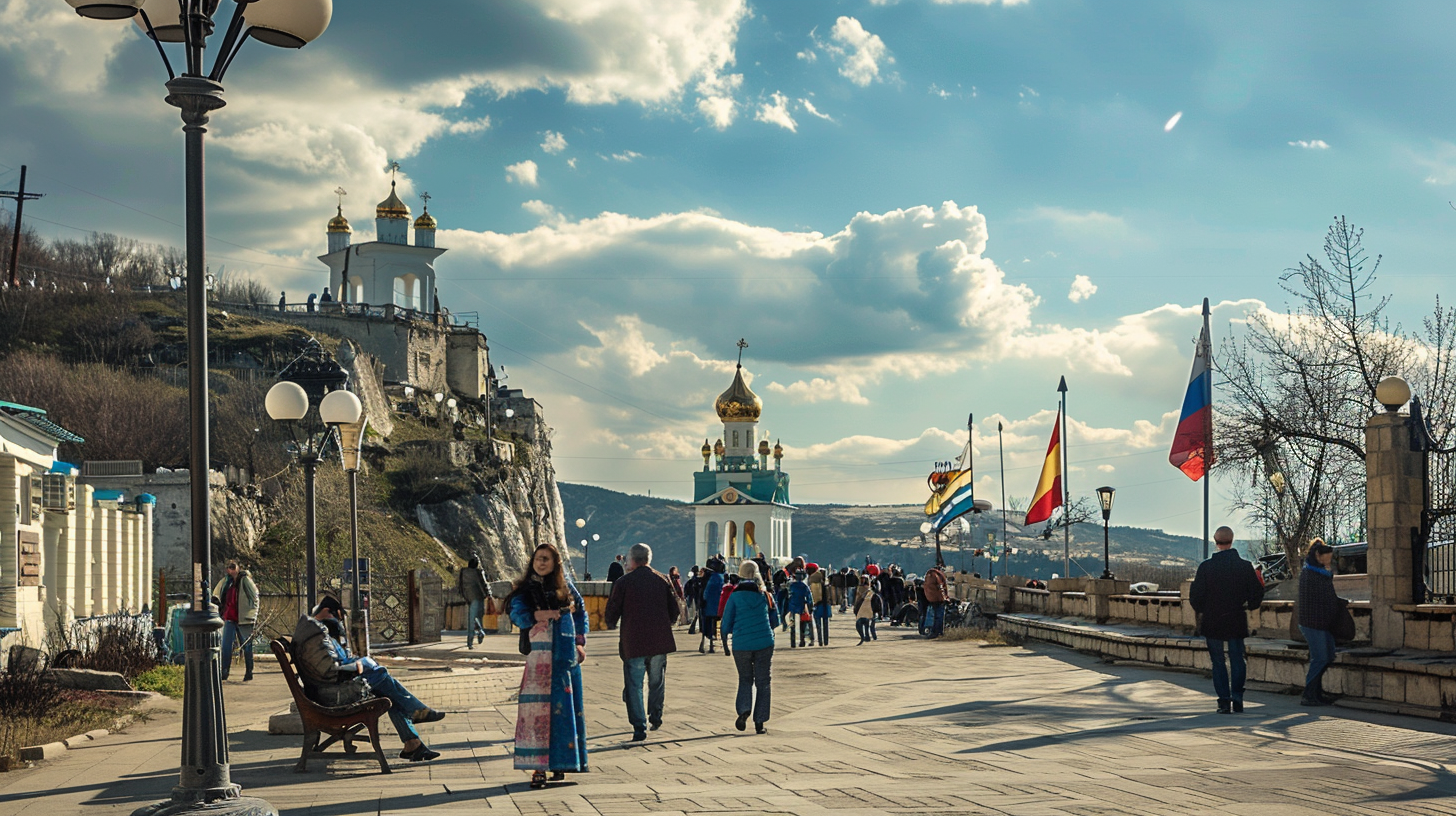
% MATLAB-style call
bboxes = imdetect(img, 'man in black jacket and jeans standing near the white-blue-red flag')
[1188,527,1264,714]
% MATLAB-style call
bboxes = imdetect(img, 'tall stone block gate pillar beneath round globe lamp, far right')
[1366,412,1425,648]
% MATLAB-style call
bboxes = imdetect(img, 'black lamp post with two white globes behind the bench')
[264,338,364,605]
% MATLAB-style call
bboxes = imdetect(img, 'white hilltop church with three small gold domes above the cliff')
[319,163,446,313]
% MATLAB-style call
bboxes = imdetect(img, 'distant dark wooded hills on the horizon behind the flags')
[561,482,1203,584]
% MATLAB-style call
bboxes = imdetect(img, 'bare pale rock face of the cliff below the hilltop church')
[415,433,566,580]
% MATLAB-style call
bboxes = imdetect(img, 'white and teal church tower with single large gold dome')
[693,340,795,567]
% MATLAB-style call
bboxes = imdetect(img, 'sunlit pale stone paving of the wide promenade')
[0,616,1456,816]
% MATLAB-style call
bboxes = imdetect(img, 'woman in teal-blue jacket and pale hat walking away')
[722,561,779,734]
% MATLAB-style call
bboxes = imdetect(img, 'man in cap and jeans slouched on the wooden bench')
[293,596,446,762]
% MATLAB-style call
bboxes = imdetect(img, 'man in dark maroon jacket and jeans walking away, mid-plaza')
[606,544,681,742]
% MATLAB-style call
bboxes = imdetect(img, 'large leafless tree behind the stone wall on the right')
[1214,217,1456,562]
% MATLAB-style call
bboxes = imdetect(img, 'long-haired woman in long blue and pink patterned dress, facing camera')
[507,544,587,788]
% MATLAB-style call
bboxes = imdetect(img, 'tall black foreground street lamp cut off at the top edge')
[66,0,333,816]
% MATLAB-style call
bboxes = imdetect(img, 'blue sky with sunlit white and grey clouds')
[0,0,1456,547]
